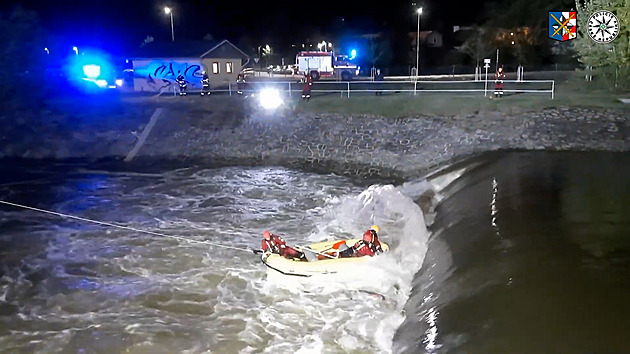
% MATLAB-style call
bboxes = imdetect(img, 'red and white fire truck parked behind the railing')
[295,52,359,81]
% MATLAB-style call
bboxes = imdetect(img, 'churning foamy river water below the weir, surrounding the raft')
[0,164,428,353]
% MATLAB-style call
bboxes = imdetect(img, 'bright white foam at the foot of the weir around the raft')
[262,182,428,353]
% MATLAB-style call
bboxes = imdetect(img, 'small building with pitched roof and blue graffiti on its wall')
[129,40,250,92]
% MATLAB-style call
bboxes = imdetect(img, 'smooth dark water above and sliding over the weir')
[394,152,630,353]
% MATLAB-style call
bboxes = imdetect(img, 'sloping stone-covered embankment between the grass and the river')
[0,97,630,179]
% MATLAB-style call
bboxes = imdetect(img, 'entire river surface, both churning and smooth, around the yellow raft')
[0,153,630,353]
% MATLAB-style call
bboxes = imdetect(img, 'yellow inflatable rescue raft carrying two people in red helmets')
[262,239,389,277]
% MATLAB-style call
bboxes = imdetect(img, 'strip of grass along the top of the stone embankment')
[24,74,630,122]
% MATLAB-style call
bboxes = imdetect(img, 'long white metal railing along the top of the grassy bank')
[158,80,555,99]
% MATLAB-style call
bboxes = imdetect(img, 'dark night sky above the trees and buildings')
[8,0,483,51]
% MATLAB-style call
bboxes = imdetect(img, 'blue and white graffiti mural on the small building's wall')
[133,59,203,92]
